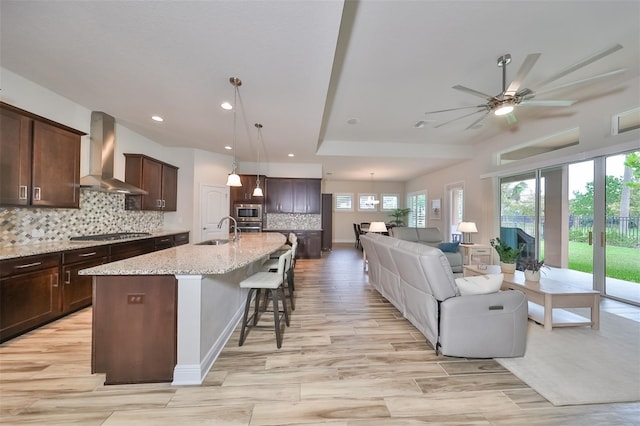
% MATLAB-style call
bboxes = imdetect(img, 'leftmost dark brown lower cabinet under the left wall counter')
[0,253,62,341]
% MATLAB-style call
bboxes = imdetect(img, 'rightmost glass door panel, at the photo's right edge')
[597,152,640,303]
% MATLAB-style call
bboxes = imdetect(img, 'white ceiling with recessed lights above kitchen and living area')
[0,0,640,181]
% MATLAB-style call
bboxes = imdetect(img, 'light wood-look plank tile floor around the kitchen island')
[0,245,640,426]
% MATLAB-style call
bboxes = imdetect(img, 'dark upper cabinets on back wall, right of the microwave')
[266,178,322,214]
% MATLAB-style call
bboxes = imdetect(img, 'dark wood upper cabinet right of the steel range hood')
[124,154,178,212]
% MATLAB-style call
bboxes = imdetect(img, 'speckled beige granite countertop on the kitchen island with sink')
[79,232,286,275]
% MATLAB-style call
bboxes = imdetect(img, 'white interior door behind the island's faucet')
[199,184,229,241]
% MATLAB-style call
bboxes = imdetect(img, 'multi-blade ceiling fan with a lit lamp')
[425,44,625,130]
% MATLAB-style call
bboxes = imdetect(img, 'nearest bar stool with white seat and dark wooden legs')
[238,250,291,349]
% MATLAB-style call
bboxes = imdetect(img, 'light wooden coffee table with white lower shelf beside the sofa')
[464,265,600,330]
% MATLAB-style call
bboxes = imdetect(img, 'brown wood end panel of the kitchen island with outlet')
[91,275,178,384]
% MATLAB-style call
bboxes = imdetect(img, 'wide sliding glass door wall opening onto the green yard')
[500,151,640,304]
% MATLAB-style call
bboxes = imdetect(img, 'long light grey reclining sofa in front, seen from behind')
[360,234,528,358]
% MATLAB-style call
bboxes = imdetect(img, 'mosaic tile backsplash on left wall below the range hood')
[0,189,164,247]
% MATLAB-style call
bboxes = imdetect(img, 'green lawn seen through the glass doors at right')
[569,241,640,283]
